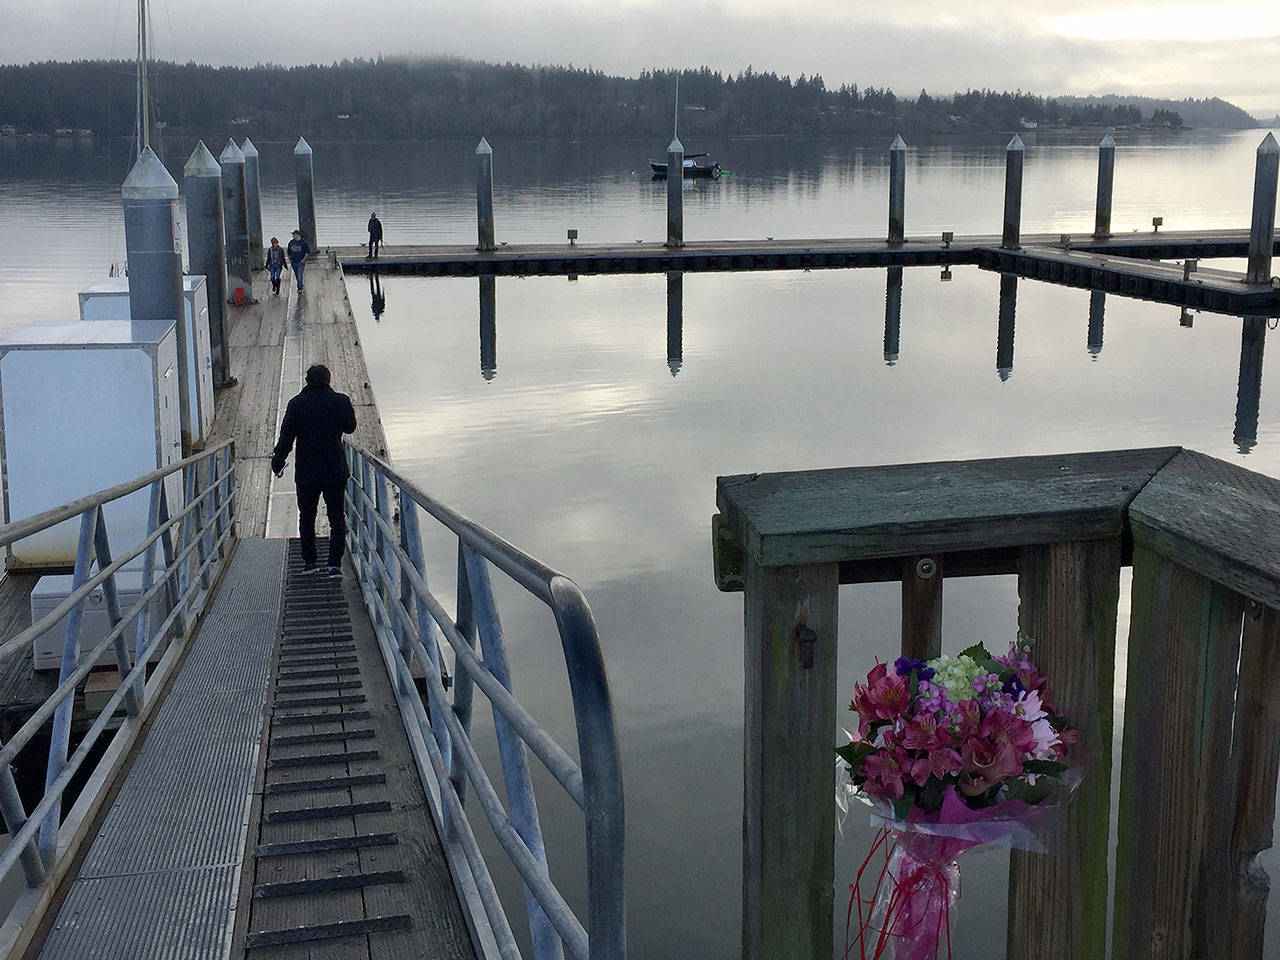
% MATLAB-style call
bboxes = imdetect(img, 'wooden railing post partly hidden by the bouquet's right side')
[1007,539,1120,960]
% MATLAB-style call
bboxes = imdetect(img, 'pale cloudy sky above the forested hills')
[0,0,1280,115]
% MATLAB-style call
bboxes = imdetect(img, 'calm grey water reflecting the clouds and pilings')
[0,131,1280,960]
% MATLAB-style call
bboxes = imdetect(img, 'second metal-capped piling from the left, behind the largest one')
[182,141,236,387]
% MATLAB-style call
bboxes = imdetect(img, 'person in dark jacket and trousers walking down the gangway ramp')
[271,364,356,577]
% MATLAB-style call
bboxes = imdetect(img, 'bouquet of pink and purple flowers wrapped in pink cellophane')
[836,635,1075,960]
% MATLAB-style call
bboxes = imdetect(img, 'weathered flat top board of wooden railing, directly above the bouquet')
[717,447,1178,566]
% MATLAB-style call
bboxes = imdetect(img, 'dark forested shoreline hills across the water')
[0,58,1256,140]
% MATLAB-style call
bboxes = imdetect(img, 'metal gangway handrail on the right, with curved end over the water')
[346,443,626,960]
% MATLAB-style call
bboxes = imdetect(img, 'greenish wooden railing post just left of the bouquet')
[742,556,840,960]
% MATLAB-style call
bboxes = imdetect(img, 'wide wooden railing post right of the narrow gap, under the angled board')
[1112,544,1244,960]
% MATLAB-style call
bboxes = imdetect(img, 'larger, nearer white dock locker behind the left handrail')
[0,320,183,570]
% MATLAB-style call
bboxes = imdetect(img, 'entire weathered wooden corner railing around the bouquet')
[713,448,1280,960]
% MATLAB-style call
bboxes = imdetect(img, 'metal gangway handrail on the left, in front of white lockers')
[0,440,236,920]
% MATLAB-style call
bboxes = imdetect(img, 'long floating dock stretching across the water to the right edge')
[332,230,1280,316]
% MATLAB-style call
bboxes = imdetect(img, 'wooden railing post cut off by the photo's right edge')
[1222,602,1280,960]
